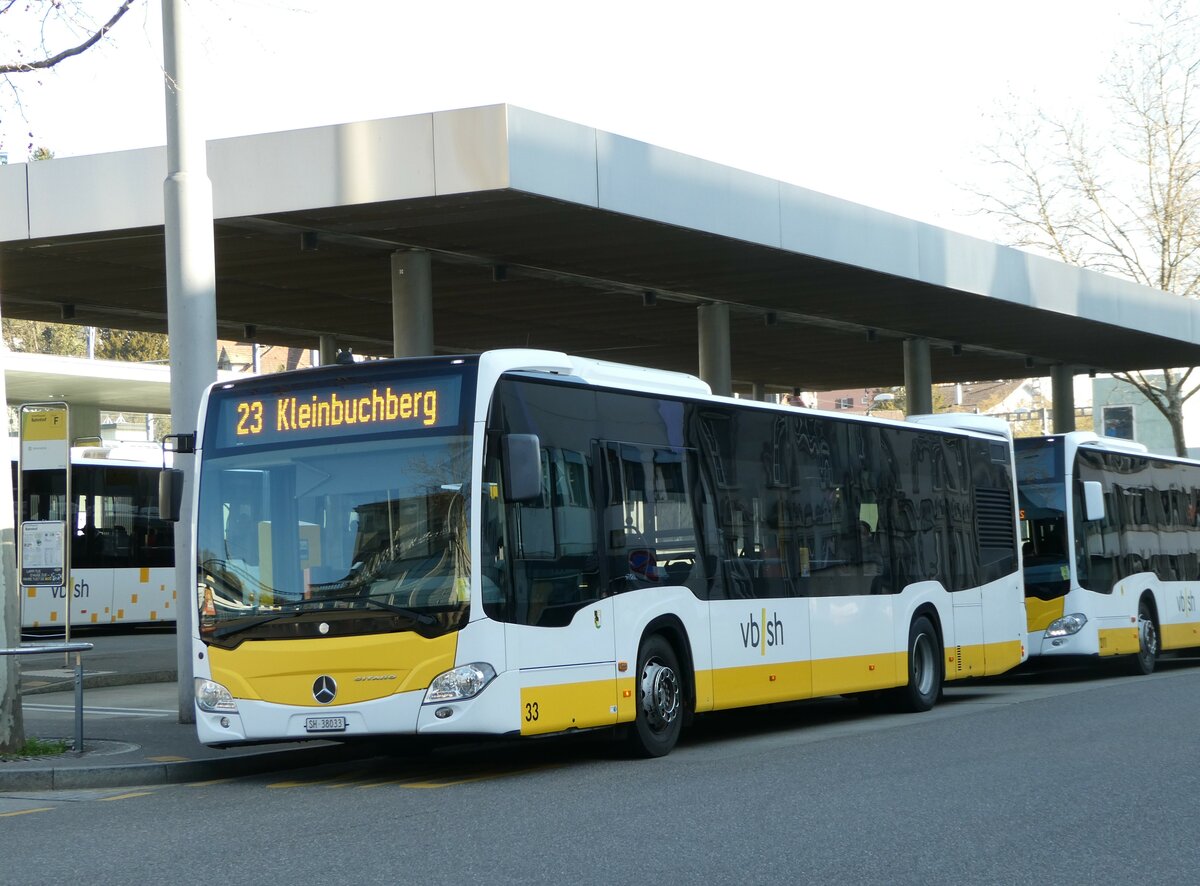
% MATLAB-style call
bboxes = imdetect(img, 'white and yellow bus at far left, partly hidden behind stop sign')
[19,443,176,634]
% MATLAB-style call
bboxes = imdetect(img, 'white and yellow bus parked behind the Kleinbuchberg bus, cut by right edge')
[1016,432,1200,674]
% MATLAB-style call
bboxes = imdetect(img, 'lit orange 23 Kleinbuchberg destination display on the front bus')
[216,376,462,447]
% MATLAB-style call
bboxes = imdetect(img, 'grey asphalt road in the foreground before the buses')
[0,658,1200,886]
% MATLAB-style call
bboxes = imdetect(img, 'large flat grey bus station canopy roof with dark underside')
[0,104,1200,390]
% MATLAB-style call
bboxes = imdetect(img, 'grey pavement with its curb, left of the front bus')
[0,634,379,791]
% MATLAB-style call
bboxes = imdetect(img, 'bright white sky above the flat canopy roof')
[0,0,1151,239]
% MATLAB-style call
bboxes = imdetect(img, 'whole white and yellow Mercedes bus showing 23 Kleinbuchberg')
[168,351,1025,755]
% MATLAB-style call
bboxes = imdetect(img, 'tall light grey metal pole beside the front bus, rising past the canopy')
[162,0,217,723]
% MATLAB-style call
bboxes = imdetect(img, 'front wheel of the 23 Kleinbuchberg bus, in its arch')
[626,618,695,758]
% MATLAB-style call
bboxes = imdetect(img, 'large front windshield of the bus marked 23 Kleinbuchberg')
[197,433,470,646]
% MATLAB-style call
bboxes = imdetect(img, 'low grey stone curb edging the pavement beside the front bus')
[0,742,379,792]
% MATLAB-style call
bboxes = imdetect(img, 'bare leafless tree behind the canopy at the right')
[982,0,1200,455]
